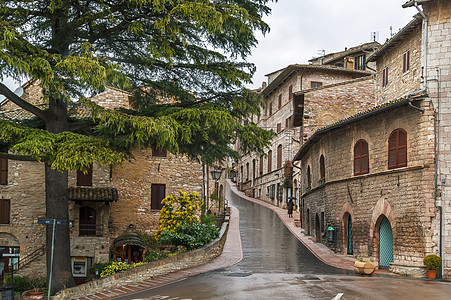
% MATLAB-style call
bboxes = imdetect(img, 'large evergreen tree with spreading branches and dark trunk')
[0,0,272,291]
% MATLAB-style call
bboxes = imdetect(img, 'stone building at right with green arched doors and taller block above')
[295,0,451,278]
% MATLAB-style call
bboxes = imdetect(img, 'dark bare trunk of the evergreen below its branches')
[45,164,75,292]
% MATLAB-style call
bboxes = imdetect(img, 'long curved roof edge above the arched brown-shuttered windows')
[293,93,426,161]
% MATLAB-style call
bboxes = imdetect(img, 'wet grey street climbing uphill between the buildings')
[116,182,451,300]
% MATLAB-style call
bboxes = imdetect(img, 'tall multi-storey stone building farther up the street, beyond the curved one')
[237,50,377,206]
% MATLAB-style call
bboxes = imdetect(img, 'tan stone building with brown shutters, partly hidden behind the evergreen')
[0,81,225,283]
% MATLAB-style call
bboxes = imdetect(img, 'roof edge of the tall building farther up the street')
[261,64,371,96]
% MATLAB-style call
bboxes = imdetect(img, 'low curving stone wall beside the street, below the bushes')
[52,217,229,299]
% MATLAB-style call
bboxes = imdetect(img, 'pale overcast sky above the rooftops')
[0,0,417,93]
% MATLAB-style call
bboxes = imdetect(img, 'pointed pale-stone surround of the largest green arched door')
[369,199,396,266]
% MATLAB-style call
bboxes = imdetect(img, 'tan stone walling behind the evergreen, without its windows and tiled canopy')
[0,81,225,282]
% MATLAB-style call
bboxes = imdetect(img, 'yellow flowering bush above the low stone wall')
[156,191,202,236]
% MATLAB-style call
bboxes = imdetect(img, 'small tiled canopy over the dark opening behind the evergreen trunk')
[68,186,119,202]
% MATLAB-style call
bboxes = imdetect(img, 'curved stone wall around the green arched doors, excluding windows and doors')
[302,101,438,274]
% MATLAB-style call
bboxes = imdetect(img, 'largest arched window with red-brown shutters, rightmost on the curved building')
[388,128,407,169]
